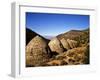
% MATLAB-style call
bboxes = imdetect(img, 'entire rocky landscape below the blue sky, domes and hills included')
[26,29,89,67]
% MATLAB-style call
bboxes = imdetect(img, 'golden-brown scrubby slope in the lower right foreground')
[56,47,89,65]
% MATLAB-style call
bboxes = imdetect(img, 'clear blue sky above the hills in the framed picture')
[26,12,89,36]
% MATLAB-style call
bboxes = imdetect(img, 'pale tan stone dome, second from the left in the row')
[48,38,63,54]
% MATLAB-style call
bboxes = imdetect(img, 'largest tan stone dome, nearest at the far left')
[26,36,49,66]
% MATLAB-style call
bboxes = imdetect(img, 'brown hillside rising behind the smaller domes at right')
[57,29,89,44]
